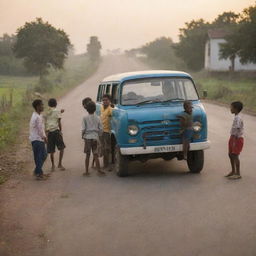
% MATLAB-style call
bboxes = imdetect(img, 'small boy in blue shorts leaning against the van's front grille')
[178,101,193,160]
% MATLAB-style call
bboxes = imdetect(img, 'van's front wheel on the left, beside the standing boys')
[114,145,129,177]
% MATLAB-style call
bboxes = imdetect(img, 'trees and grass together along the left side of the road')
[0,18,101,184]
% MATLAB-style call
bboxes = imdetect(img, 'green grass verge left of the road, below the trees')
[0,55,98,152]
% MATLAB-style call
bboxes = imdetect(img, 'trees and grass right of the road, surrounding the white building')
[126,2,256,113]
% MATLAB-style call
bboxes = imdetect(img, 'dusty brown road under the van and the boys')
[0,57,256,256]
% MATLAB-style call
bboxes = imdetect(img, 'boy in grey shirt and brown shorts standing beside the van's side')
[82,101,105,176]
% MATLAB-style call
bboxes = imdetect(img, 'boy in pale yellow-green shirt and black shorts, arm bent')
[45,98,66,171]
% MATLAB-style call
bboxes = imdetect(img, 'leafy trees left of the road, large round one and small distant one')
[0,18,101,82]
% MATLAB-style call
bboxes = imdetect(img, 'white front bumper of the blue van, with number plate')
[120,141,210,155]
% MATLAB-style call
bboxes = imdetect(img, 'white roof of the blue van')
[102,70,191,82]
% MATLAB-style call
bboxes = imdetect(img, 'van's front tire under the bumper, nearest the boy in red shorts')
[187,150,204,173]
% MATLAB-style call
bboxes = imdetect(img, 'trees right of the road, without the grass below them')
[127,5,256,71]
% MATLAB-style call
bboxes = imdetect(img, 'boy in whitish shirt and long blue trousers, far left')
[29,99,48,180]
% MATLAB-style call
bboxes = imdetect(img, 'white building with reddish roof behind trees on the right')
[204,29,256,71]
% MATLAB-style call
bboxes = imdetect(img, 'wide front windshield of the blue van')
[121,78,198,105]
